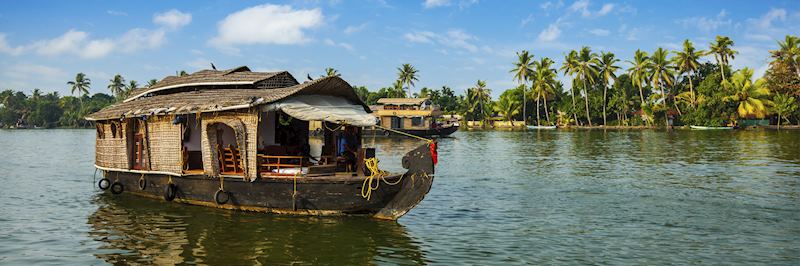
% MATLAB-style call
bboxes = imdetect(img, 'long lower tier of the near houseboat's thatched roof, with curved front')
[86,77,370,121]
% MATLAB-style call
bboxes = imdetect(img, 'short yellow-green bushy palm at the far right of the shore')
[722,68,772,118]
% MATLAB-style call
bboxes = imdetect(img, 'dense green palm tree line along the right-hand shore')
[357,35,800,126]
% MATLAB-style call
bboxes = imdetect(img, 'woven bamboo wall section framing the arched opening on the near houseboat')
[201,110,258,180]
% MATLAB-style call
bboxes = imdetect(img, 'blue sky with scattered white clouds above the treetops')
[0,0,800,96]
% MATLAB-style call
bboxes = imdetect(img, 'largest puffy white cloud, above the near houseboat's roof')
[209,4,324,48]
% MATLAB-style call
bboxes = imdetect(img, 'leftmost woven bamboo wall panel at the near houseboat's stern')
[95,122,128,169]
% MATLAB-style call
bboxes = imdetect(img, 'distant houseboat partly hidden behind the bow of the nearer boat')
[365,98,459,137]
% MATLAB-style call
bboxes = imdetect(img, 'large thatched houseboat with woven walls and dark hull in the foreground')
[86,67,436,220]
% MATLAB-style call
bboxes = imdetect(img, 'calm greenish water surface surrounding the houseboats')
[0,130,800,265]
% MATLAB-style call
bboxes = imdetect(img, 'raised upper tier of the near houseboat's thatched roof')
[125,66,297,102]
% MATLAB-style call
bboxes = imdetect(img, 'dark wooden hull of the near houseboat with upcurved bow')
[104,145,433,220]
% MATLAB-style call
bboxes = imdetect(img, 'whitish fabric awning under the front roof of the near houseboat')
[267,95,377,127]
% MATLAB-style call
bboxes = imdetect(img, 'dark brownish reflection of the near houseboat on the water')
[88,195,427,265]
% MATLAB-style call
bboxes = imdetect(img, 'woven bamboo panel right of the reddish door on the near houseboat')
[145,115,182,174]
